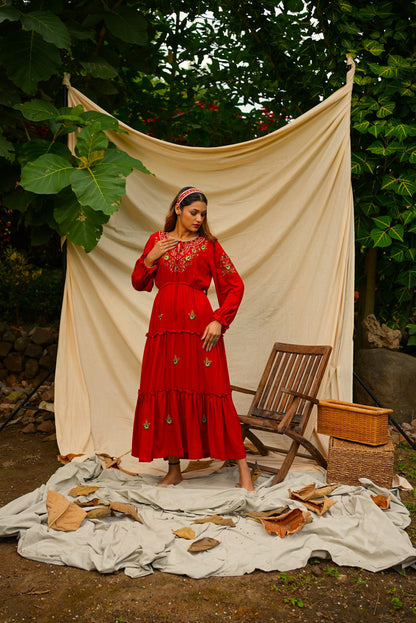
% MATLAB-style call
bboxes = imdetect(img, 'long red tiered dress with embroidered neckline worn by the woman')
[132,232,245,461]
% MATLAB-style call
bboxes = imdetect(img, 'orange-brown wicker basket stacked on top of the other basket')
[317,400,393,446]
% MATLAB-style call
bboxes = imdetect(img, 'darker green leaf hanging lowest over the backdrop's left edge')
[53,188,110,253]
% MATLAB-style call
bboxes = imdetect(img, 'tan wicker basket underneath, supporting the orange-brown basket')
[327,437,394,489]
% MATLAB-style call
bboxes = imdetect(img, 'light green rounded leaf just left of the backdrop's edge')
[20,154,74,195]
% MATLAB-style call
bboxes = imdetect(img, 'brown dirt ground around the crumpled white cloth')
[0,424,416,623]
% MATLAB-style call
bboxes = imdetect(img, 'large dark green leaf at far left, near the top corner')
[0,31,61,94]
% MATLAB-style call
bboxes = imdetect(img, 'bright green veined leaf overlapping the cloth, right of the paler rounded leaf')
[71,162,126,214]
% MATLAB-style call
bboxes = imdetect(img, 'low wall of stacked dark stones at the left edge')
[0,322,58,386]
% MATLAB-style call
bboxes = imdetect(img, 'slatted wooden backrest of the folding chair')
[249,342,332,427]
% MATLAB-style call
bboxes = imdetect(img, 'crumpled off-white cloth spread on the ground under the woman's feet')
[0,458,416,578]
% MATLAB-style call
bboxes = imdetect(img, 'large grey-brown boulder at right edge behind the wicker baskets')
[354,348,416,424]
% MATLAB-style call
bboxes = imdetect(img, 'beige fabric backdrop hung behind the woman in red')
[55,71,354,464]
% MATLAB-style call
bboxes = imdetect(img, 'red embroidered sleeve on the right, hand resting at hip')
[213,242,244,331]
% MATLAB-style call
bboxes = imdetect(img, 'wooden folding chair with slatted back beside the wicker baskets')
[231,342,332,484]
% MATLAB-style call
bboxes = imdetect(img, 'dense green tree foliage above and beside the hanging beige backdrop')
[0,0,416,325]
